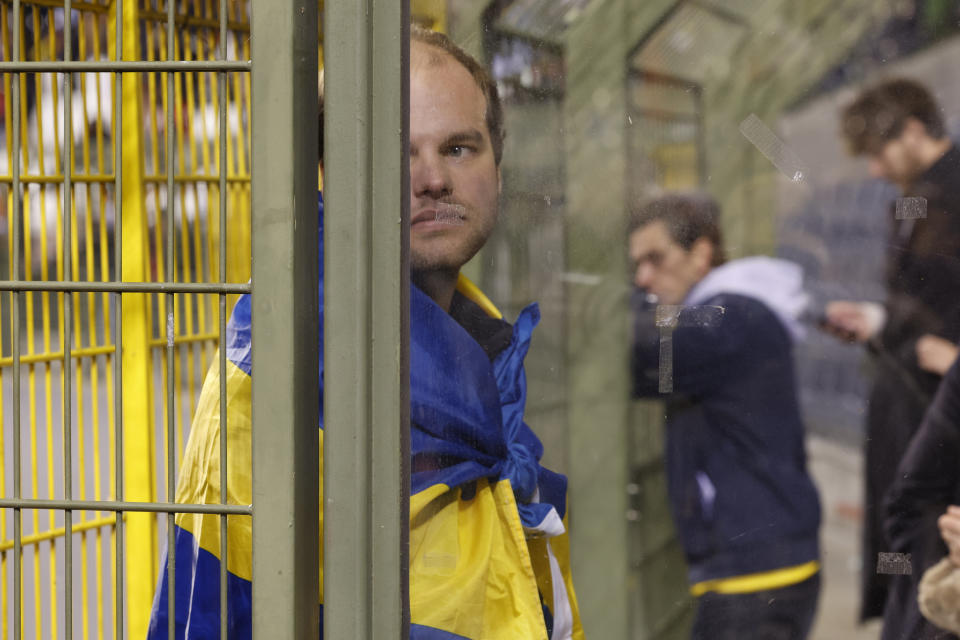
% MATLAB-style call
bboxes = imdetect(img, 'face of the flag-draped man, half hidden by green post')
[410,42,500,271]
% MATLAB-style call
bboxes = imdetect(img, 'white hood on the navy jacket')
[683,256,810,340]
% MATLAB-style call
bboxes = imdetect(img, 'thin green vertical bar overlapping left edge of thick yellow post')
[113,0,124,640]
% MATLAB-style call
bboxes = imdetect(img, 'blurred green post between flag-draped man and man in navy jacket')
[564,0,630,639]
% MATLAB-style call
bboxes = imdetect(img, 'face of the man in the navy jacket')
[629,220,712,304]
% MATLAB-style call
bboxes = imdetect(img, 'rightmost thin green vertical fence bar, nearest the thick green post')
[217,0,229,640]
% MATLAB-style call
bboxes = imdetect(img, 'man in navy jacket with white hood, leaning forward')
[629,194,820,640]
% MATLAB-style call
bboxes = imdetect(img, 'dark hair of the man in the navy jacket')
[627,192,726,267]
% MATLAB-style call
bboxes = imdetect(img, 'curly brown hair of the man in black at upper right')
[841,78,947,155]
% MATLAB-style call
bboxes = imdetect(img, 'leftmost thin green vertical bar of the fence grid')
[10,0,23,640]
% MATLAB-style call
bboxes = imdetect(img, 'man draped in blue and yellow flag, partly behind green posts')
[149,27,583,640]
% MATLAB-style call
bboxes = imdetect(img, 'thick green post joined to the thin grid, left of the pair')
[251,0,320,640]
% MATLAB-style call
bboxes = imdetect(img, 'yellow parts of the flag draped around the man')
[176,357,583,640]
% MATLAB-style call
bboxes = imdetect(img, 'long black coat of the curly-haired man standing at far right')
[861,147,960,619]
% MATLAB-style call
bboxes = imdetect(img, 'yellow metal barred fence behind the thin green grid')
[0,0,251,638]
